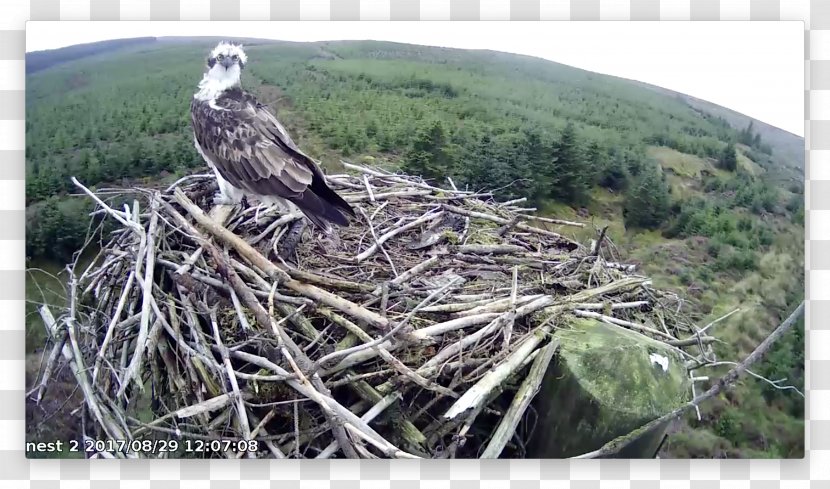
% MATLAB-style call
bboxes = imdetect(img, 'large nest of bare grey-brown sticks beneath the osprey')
[38,165,712,458]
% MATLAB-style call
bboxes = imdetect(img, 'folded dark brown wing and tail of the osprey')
[191,89,354,228]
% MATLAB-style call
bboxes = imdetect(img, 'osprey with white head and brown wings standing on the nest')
[190,42,355,233]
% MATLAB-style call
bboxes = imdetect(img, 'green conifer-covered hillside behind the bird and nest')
[26,40,804,457]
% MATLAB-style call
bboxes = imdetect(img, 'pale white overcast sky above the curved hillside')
[26,21,804,136]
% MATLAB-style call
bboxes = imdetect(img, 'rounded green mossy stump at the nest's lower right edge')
[534,319,691,458]
